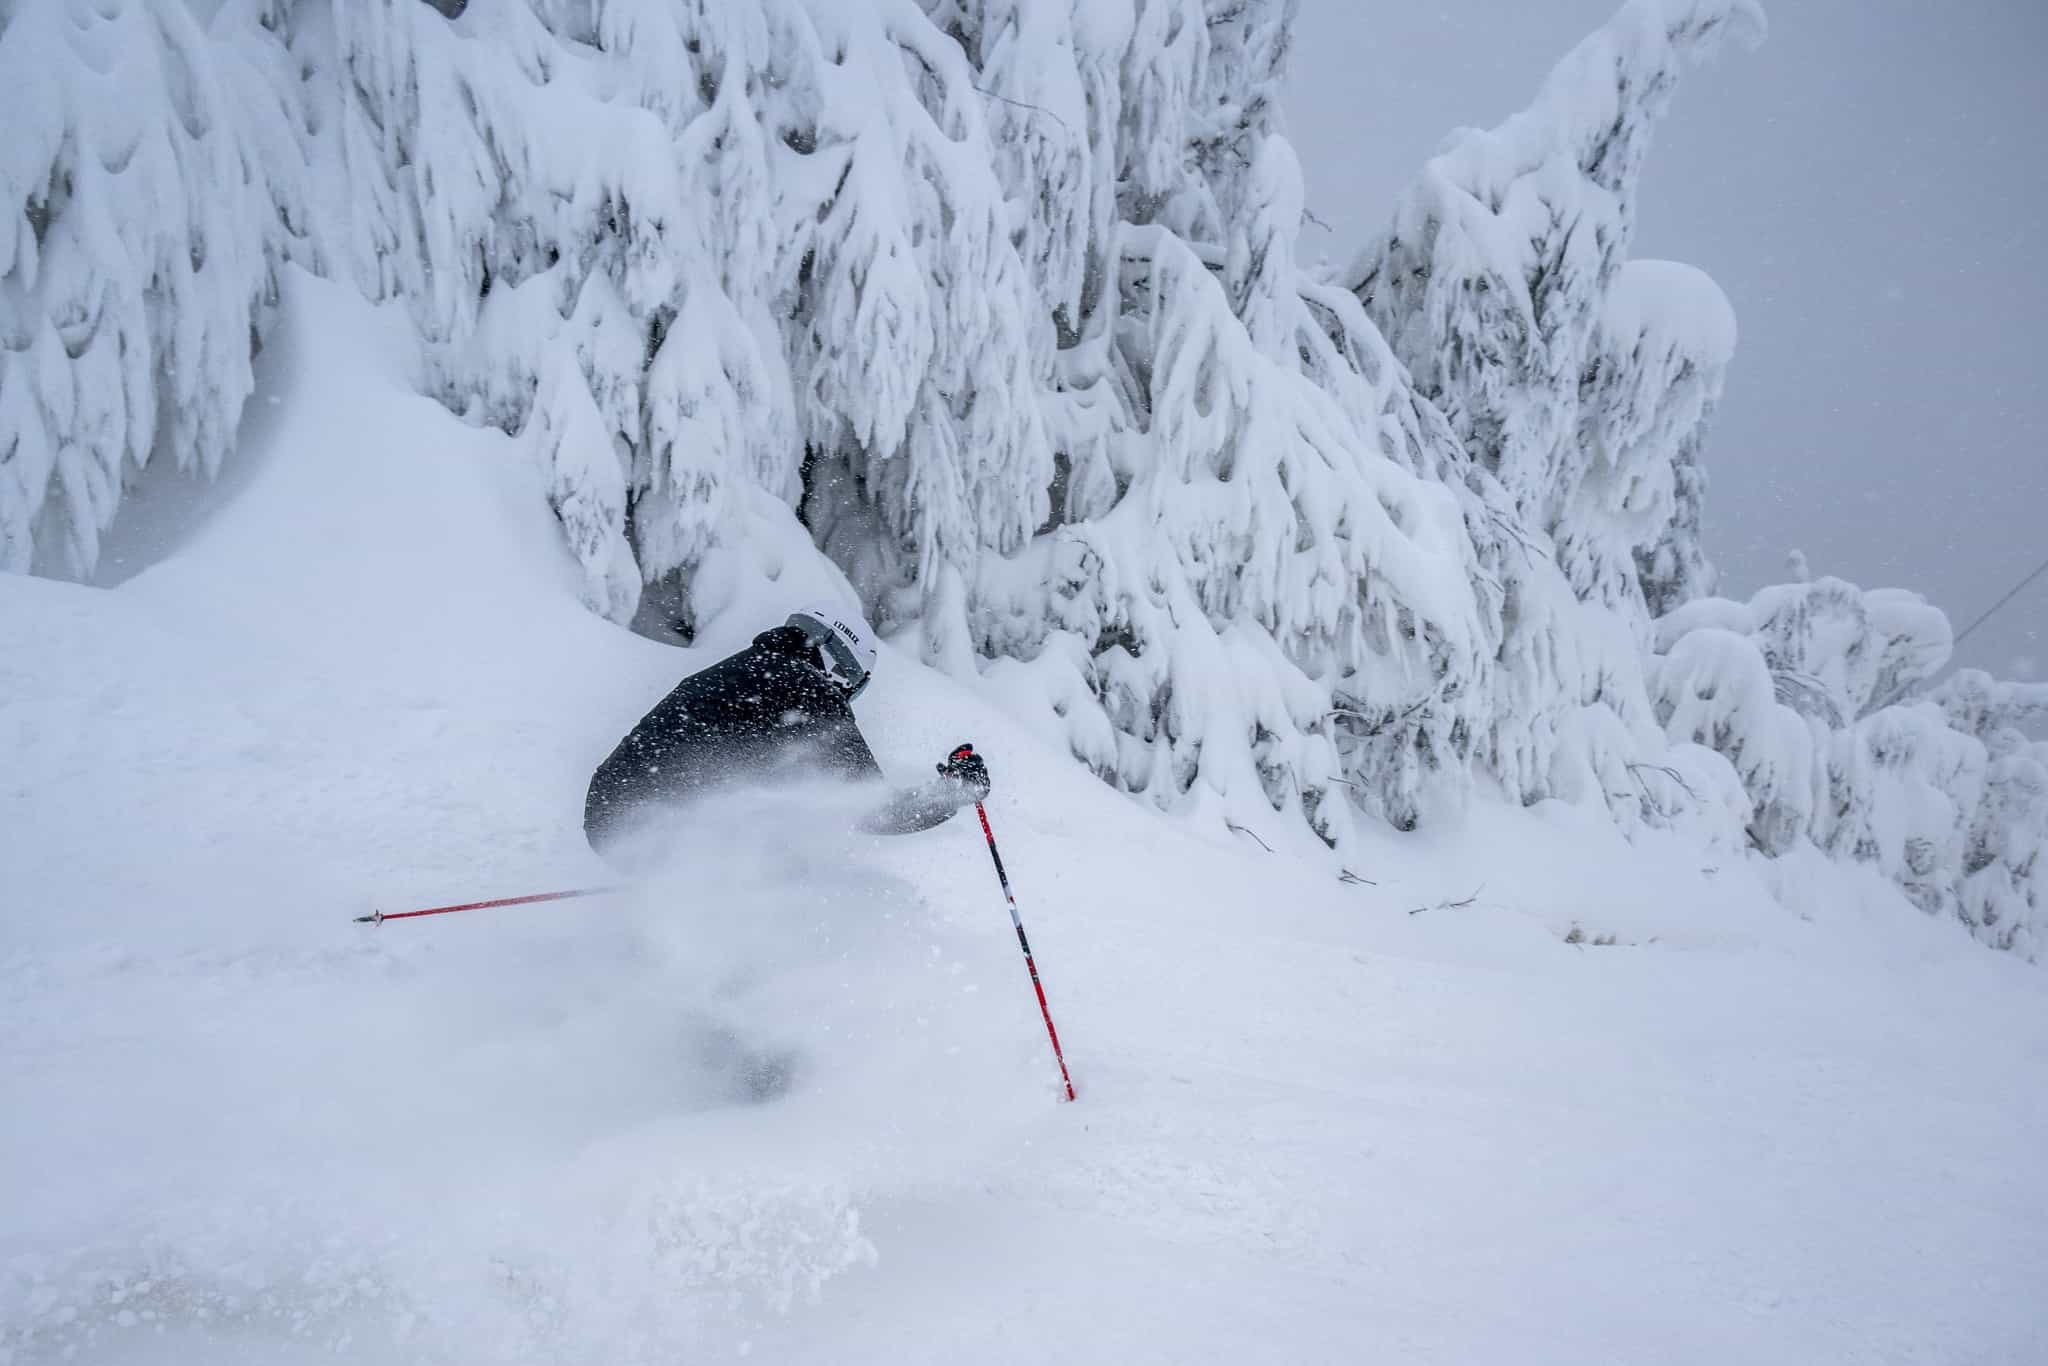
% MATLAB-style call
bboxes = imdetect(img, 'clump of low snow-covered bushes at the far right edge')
[1651,578,2048,956]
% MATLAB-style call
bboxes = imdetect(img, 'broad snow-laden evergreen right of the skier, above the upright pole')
[948,2,1572,840]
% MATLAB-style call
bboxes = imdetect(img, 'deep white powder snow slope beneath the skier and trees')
[12,279,2048,1366]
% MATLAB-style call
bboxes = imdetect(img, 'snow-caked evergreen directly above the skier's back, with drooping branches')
[307,0,805,621]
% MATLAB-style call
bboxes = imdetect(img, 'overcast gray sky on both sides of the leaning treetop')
[1288,0,2048,678]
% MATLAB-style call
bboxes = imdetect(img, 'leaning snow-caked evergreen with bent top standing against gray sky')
[1350,0,1763,630]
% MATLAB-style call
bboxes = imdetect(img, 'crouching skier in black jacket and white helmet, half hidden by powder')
[584,608,989,864]
